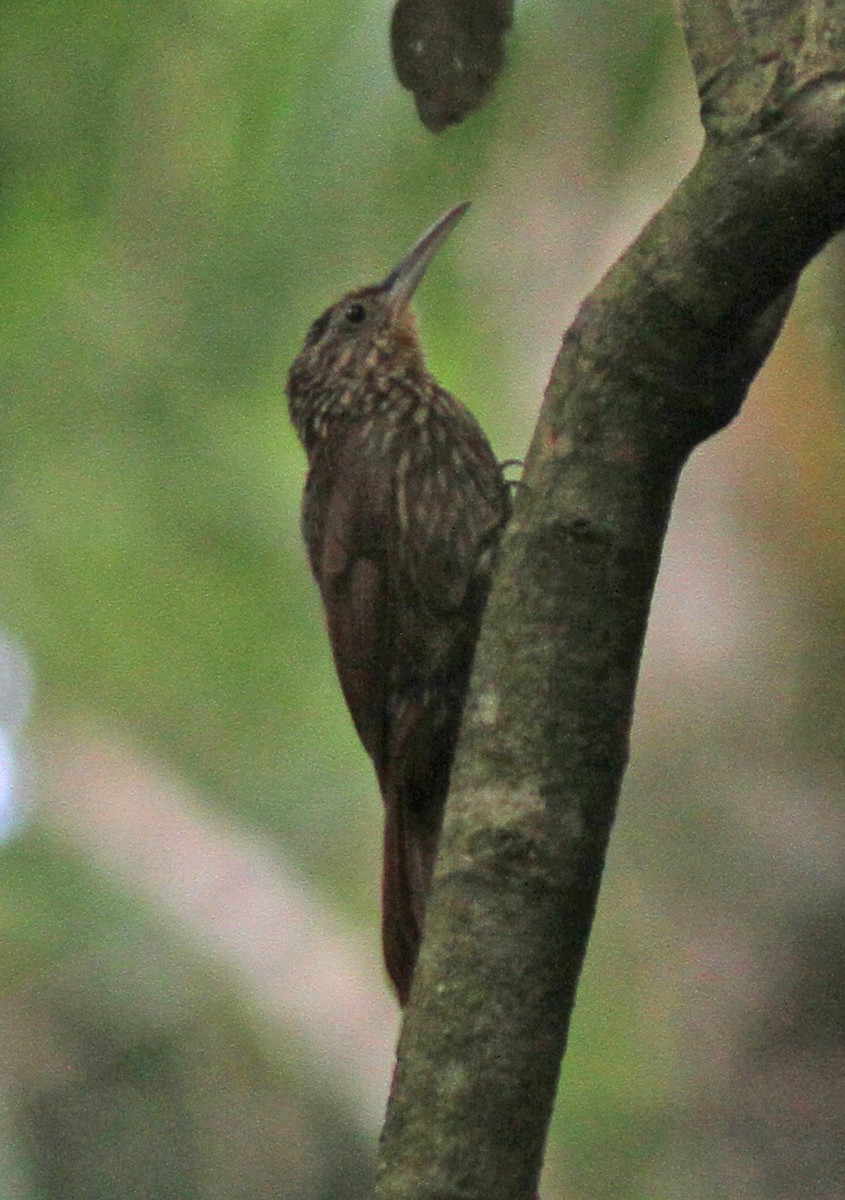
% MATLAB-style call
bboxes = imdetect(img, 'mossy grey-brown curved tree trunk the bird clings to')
[377,0,845,1200]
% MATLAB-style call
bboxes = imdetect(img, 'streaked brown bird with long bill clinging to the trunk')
[287,204,510,1004]
